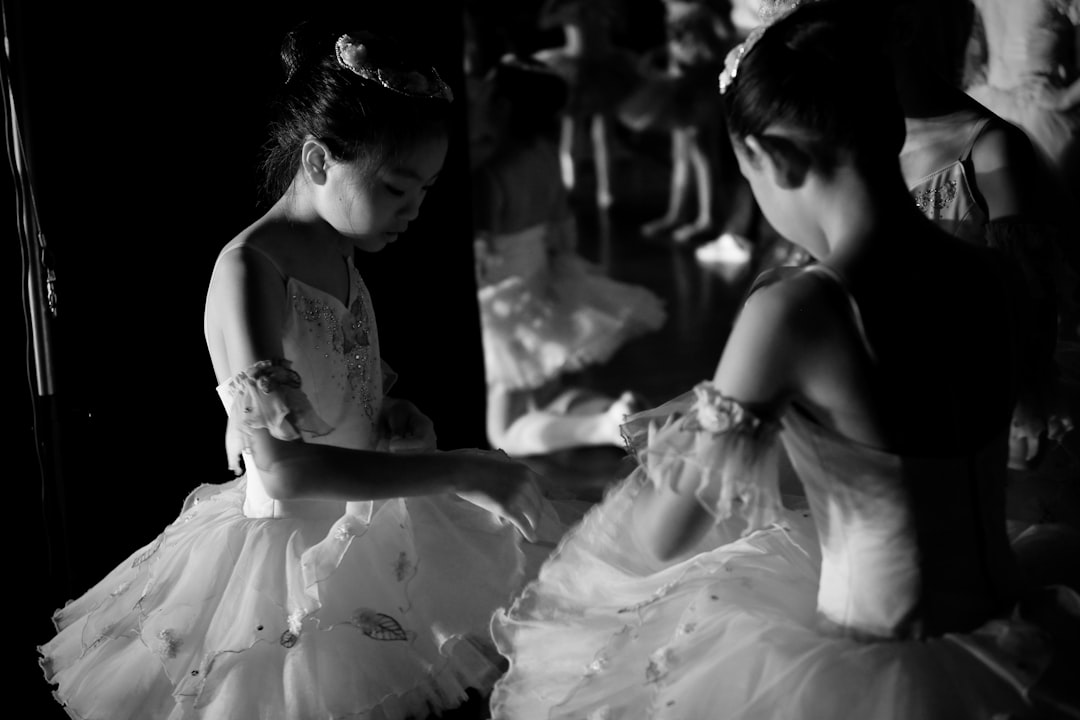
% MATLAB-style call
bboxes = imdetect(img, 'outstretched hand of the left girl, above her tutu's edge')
[454,450,542,542]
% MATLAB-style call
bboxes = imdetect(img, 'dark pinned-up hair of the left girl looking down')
[262,23,449,202]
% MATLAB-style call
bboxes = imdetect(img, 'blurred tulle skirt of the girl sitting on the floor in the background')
[480,253,666,389]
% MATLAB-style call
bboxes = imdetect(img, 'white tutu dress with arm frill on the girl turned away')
[491,266,1080,720]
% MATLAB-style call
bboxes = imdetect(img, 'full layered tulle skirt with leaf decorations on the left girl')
[39,480,525,720]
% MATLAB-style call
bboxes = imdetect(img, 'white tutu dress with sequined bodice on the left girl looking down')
[39,245,535,720]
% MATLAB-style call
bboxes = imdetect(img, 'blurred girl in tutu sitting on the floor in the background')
[470,55,665,456]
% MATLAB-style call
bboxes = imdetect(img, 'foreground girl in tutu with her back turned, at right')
[491,0,1080,720]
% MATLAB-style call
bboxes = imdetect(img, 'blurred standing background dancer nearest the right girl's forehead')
[619,0,734,244]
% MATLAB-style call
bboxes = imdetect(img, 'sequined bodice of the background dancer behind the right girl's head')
[900,111,988,245]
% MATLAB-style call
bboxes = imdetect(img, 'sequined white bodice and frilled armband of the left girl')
[208,245,392,517]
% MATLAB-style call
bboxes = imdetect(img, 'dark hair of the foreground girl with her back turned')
[724,0,905,172]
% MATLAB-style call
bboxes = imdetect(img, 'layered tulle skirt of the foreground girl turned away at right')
[491,475,1080,720]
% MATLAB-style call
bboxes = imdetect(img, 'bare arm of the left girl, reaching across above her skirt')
[210,247,540,538]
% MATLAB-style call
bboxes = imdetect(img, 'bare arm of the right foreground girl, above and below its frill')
[633,285,799,561]
